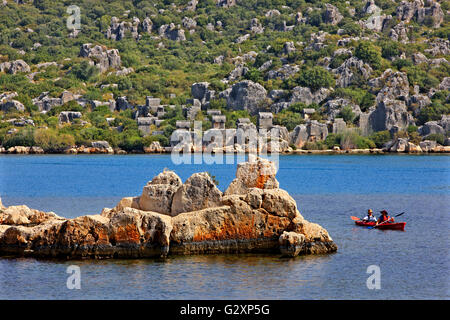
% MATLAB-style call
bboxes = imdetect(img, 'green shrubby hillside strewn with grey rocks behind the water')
[0,0,450,152]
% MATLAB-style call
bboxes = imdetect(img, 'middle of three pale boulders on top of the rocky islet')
[171,172,222,216]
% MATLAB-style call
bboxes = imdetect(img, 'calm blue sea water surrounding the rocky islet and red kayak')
[0,155,450,299]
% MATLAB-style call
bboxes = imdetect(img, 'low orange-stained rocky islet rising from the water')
[0,158,337,259]
